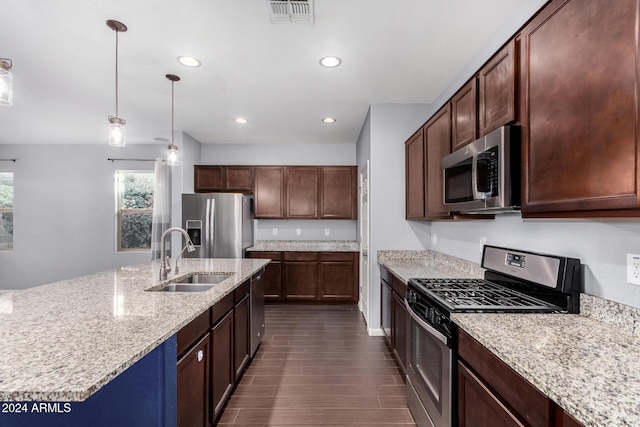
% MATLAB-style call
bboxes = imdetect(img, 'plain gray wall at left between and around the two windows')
[0,144,166,290]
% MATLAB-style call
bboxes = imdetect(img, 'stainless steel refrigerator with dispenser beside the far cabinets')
[182,193,253,258]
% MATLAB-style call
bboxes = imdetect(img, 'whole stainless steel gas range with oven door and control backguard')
[405,246,583,427]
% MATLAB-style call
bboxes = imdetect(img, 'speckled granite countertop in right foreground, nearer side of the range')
[451,313,640,427]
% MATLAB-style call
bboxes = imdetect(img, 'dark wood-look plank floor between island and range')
[218,305,415,427]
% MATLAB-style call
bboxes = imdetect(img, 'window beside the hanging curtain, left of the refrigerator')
[116,171,154,251]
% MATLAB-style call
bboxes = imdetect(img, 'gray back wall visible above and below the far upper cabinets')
[200,143,357,240]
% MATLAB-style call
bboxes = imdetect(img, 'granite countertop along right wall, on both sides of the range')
[378,251,640,427]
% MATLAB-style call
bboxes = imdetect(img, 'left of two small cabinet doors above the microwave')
[451,77,478,151]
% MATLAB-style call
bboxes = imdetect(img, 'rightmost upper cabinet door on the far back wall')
[320,166,358,219]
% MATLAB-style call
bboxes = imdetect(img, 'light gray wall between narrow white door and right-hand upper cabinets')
[357,104,431,333]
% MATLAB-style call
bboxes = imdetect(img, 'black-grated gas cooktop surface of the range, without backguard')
[411,279,562,312]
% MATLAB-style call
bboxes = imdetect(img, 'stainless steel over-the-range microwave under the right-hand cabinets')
[442,126,521,213]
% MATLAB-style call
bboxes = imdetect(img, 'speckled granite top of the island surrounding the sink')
[0,259,268,401]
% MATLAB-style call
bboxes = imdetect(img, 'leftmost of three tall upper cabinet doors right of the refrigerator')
[253,166,284,219]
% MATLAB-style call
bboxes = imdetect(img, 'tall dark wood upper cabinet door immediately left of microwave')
[424,104,451,218]
